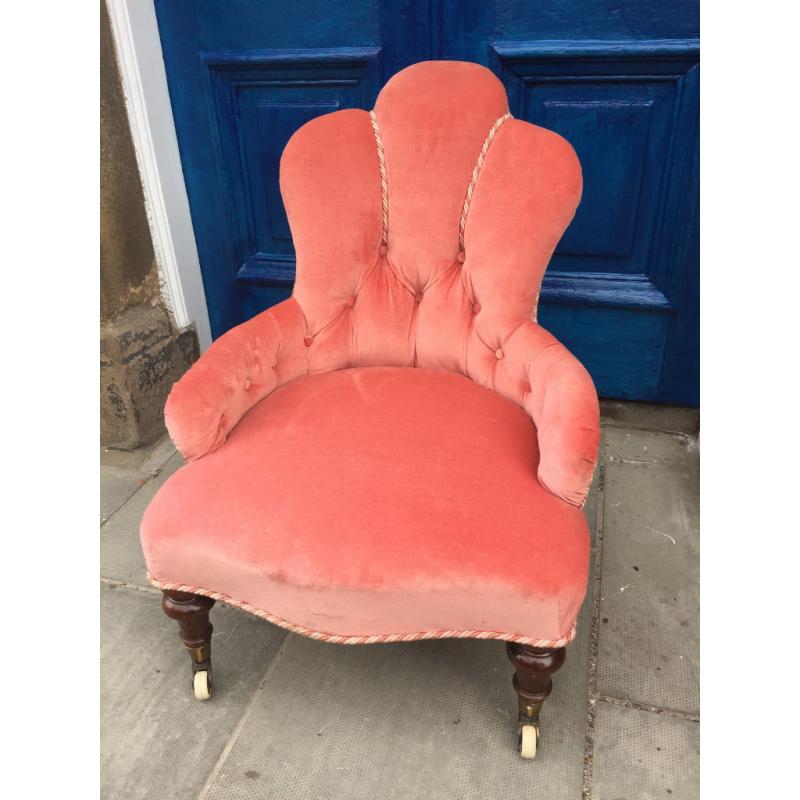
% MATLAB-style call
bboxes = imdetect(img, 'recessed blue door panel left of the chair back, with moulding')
[202,48,380,286]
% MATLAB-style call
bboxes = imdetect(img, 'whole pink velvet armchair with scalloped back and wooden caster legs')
[141,61,599,757]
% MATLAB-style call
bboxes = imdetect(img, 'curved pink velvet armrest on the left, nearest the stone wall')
[164,298,308,461]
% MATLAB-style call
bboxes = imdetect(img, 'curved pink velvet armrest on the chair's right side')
[506,322,600,507]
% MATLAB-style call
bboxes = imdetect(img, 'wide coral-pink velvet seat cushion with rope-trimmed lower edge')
[141,367,589,646]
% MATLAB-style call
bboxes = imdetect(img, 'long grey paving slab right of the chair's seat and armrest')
[597,430,699,715]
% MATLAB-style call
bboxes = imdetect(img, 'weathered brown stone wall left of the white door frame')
[100,0,198,449]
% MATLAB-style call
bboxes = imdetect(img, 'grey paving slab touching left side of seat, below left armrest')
[100,454,184,586]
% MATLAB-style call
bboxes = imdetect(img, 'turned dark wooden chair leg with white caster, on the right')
[506,642,567,758]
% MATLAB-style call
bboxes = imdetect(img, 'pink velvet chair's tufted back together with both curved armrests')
[165,61,599,505]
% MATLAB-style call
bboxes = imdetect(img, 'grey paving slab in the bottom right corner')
[592,702,700,800]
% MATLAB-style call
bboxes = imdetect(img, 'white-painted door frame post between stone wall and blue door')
[106,0,211,351]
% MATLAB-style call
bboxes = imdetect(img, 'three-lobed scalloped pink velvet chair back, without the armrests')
[280,61,581,390]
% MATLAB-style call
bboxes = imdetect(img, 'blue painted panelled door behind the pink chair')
[156,0,699,405]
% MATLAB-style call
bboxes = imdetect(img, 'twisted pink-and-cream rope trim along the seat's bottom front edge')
[147,573,575,648]
